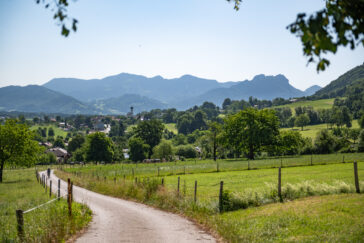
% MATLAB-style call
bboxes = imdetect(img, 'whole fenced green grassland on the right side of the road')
[56,154,364,242]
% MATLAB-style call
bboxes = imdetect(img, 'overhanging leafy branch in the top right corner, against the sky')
[287,0,364,71]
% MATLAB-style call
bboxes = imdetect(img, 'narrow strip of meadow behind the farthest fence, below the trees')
[63,153,364,180]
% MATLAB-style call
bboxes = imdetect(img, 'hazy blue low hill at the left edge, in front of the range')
[0,85,96,114]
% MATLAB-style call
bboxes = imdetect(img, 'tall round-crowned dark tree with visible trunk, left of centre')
[134,119,164,158]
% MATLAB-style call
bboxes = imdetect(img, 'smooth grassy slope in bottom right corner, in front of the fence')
[215,194,364,242]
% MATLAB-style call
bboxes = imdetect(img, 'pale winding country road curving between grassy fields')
[42,171,216,243]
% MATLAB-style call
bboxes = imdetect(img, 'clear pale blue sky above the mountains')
[0,0,364,89]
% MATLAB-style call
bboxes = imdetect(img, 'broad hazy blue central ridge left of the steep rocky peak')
[43,73,233,103]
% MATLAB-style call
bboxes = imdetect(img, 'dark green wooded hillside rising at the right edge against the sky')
[312,64,364,99]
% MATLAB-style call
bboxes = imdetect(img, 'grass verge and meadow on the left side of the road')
[0,169,91,242]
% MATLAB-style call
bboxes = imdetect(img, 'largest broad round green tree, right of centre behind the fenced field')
[224,108,279,159]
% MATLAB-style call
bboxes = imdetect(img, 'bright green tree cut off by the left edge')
[0,119,41,183]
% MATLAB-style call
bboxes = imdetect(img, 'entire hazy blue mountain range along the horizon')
[0,73,321,114]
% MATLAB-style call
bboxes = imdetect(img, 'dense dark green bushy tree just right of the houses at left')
[85,132,113,162]
